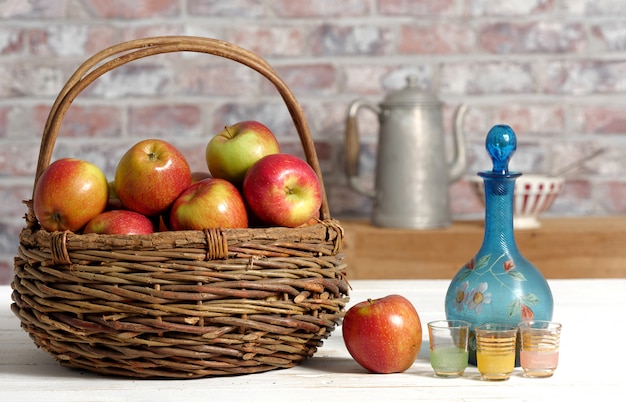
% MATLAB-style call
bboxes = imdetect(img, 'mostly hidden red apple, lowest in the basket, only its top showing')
[83,209,154,234]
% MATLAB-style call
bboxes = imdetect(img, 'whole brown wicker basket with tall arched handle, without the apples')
[11,36,349,378]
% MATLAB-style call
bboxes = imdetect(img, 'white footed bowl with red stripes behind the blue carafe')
[468,174,565,229]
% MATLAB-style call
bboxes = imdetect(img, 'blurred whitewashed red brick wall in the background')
[0,0,626,283]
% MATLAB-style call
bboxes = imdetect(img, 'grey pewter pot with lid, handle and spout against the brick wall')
[345,76,467,229]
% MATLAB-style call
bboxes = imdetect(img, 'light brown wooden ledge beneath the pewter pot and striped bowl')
[340,216,626,280]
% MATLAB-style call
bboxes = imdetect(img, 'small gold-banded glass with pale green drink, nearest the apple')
[428,320,470,377]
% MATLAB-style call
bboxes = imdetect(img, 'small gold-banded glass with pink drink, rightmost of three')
[518,321,561,377]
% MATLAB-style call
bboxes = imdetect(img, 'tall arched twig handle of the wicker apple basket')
[33,36,330,220]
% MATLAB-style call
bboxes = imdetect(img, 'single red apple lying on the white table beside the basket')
[342,295,422,374]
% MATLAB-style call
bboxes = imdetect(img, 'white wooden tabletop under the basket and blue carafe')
[0,279,626,402]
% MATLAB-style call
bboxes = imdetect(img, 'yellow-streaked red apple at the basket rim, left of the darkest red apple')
[170,178,248,230]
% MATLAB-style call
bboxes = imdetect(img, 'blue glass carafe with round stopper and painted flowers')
[445,125,554,365]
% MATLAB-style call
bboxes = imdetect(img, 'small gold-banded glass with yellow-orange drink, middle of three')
[474,323,517,381]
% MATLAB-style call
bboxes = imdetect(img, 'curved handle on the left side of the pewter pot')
[345,99,380,198]
